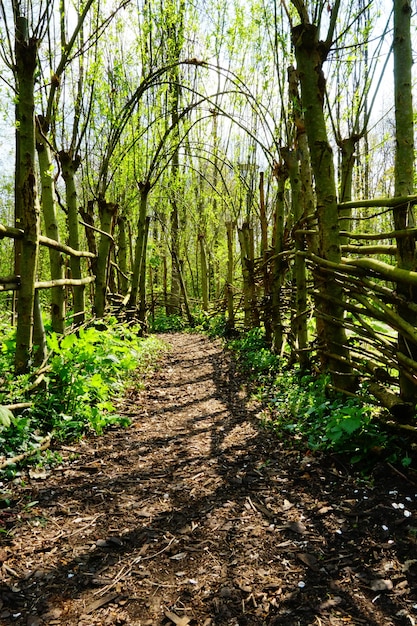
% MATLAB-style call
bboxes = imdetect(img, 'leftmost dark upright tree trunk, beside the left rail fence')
[15,16,40,374]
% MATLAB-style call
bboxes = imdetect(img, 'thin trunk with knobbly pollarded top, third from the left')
[58,151,85,326]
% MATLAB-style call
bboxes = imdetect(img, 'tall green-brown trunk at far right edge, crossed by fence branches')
[394,0,417,405]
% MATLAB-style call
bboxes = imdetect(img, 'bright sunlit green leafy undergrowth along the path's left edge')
[0,319,163,466]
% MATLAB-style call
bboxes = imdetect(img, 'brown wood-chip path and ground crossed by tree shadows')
[0,334,417,626]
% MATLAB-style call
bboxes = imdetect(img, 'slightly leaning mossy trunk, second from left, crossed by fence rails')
[36,120,65,335]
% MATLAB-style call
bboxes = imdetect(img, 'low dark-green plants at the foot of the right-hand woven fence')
[228,329,402,464]
